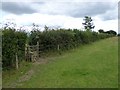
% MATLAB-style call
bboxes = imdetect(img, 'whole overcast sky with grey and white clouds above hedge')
[0,0,118,32]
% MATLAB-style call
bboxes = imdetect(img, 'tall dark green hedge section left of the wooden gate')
[2,28,27,69]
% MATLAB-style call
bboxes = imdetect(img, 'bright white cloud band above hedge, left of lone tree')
[1,13,81,28]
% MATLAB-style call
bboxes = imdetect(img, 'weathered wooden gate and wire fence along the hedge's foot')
[25,43,77,62]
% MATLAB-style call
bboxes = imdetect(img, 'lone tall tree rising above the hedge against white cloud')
[82,16,95,30]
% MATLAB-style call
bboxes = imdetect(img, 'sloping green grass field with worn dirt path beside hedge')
[3,37,118,88]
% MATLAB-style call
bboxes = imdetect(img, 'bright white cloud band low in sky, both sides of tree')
[0,13,118,32]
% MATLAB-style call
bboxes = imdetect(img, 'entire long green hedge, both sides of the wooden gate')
[2,26,114,69]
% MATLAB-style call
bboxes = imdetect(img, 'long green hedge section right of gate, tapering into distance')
[29,29,112,51]
